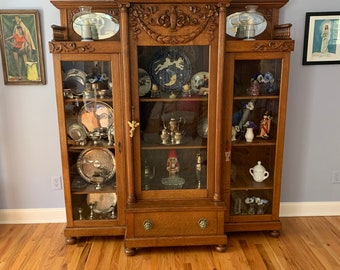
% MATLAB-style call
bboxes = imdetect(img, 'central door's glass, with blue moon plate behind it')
[137,46,209,194]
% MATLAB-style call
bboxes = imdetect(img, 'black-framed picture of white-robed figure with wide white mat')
[302,11,340,65]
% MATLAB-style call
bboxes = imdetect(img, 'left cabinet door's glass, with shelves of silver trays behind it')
[60,61,119,222]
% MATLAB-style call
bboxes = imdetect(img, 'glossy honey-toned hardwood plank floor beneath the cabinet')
[0,216,340,270]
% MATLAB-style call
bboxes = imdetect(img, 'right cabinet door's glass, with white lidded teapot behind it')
[230,59,283,220]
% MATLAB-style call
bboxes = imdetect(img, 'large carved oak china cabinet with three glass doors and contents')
[49,0,294,255]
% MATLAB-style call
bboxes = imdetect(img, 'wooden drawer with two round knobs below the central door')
[129,211,219,237]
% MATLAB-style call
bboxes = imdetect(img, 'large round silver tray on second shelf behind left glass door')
[78,101,113,133]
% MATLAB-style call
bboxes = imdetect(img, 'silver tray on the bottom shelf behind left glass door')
[87,193,117,214]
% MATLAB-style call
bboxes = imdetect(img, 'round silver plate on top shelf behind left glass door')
[64,68,87,96]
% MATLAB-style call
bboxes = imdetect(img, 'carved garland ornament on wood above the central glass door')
[130,4,218,44]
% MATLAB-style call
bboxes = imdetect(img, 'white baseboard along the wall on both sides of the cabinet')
[0,201,340,224]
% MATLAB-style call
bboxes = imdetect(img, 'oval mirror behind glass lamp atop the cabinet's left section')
[73,13,119,40]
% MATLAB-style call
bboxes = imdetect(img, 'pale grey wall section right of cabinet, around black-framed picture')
[281,0,340,202]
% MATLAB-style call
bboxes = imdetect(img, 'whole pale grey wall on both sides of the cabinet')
[0,0,340,209]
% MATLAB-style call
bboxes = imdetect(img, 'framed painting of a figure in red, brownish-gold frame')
[0,10,46,85]
